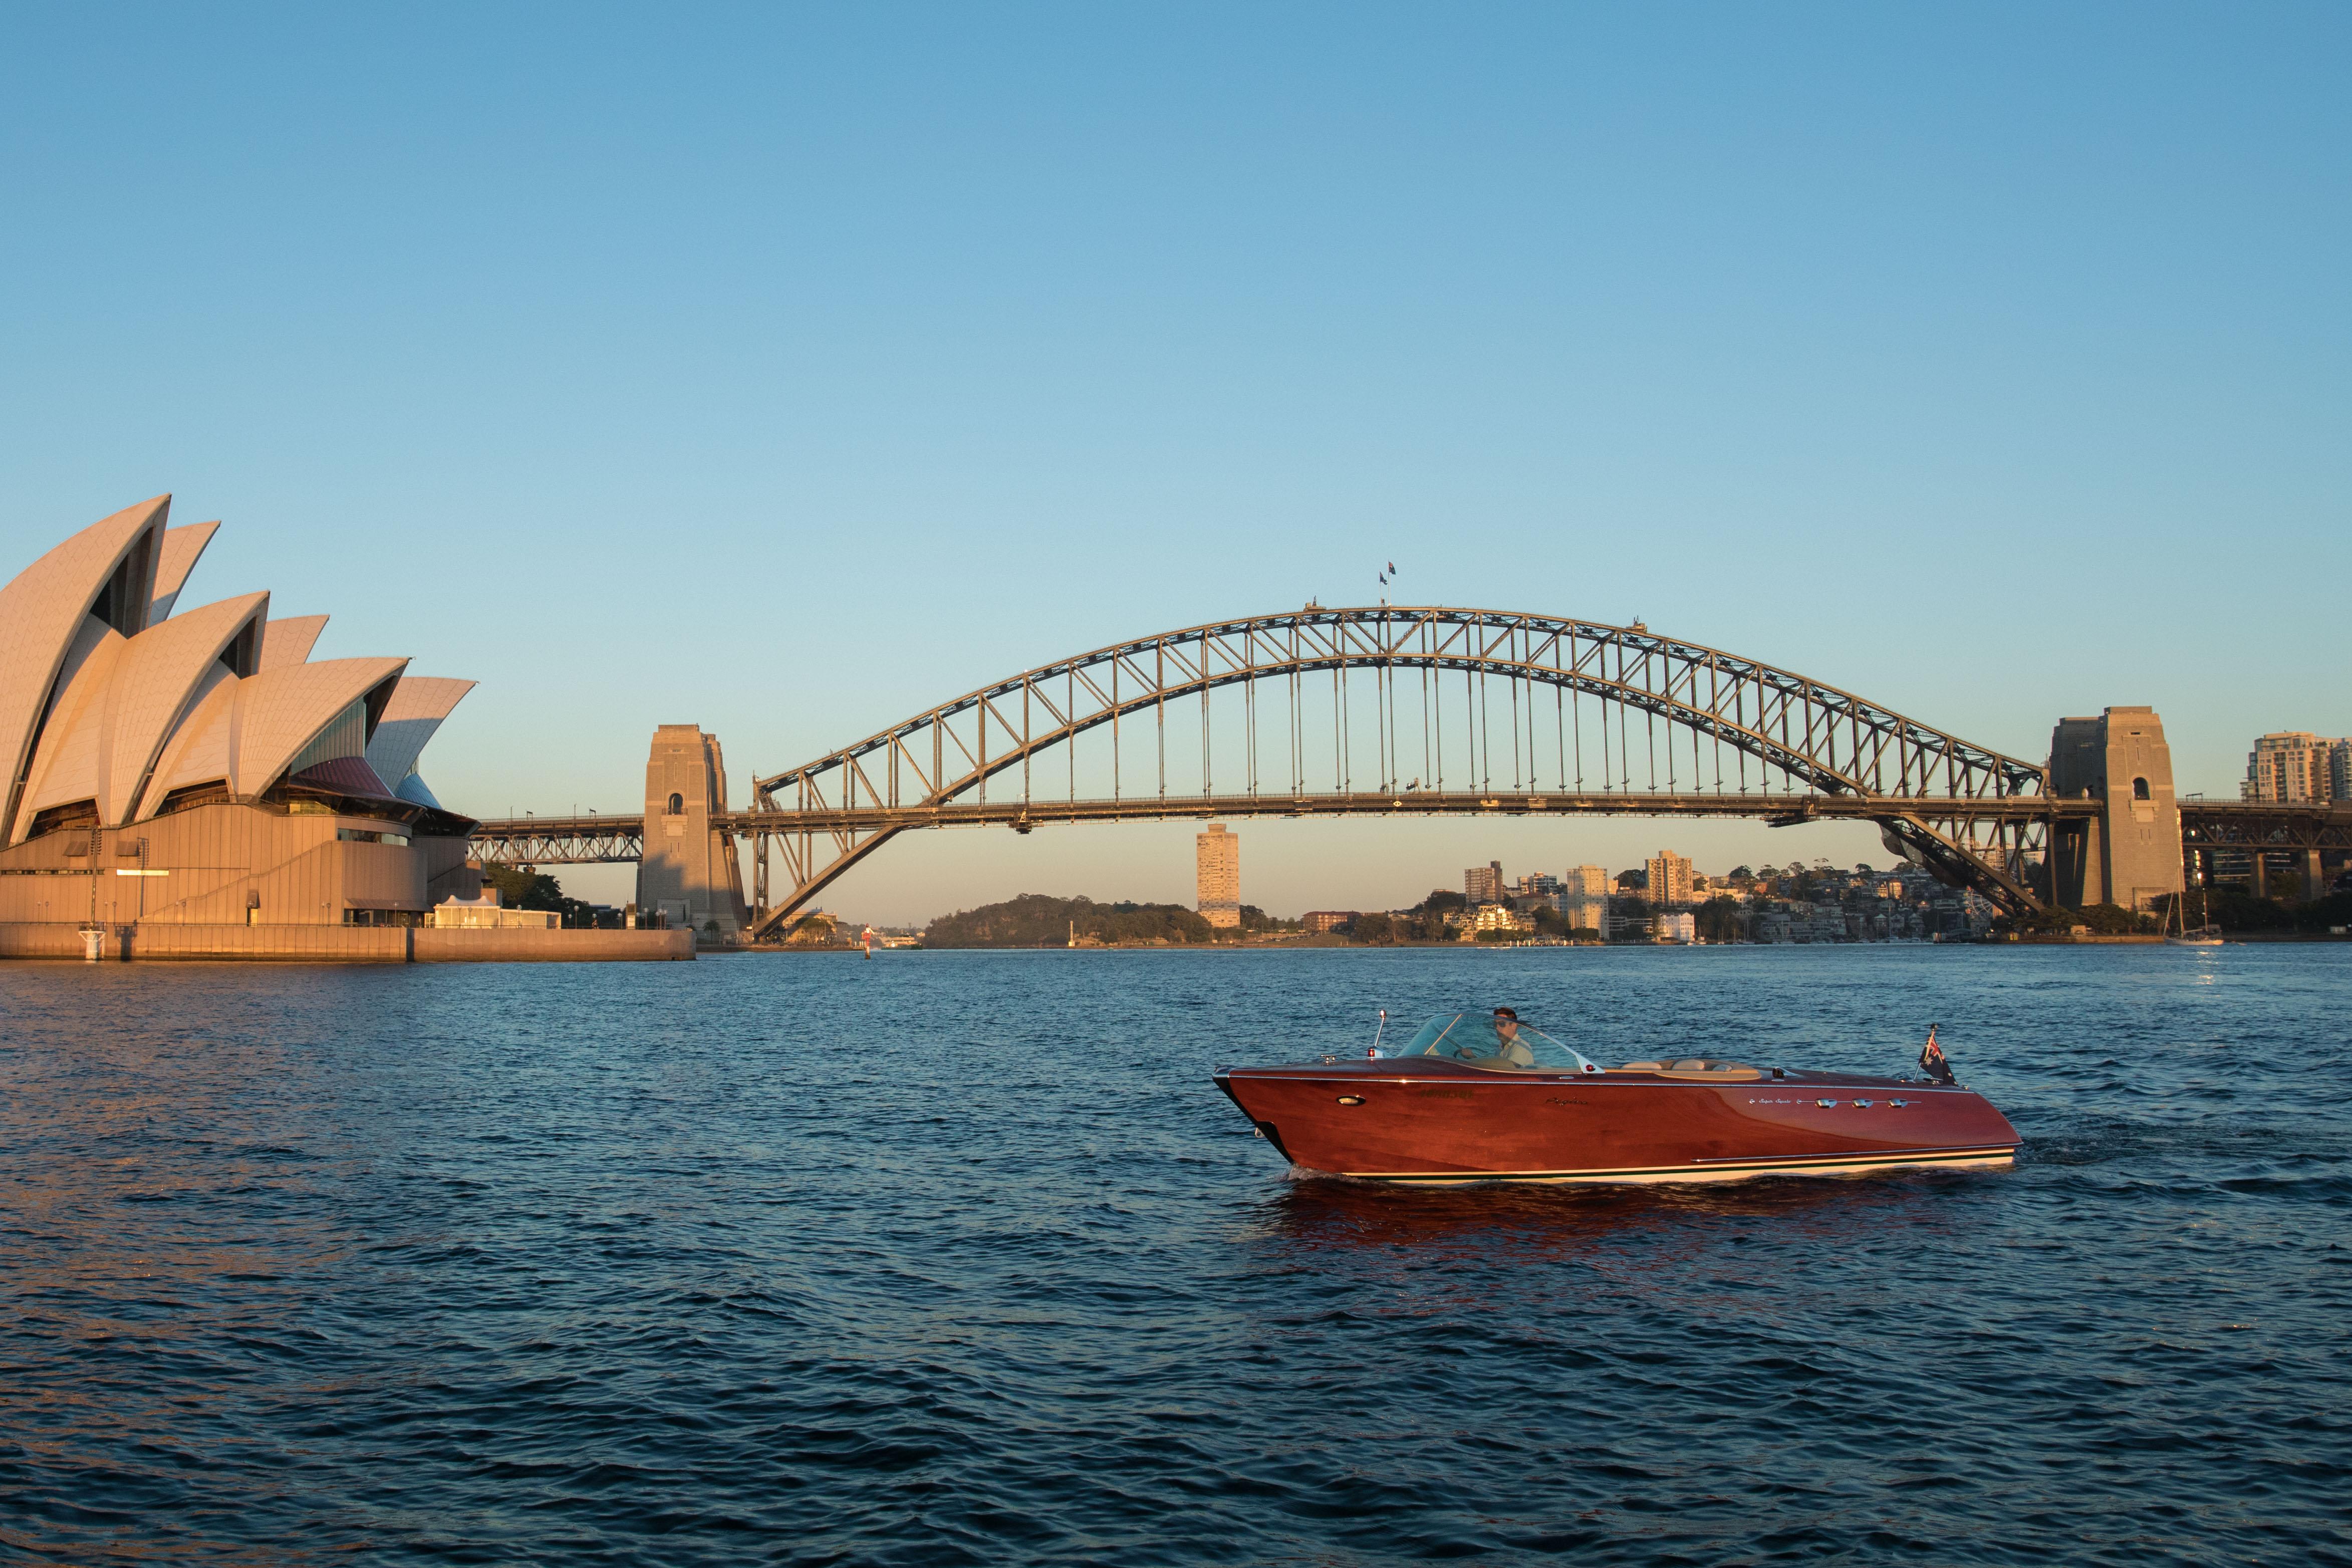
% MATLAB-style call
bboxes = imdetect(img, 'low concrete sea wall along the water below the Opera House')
[0,922,694,964]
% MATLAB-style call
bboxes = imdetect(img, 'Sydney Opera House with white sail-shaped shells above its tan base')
[0,496,480,957]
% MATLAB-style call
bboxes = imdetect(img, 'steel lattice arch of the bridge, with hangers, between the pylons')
[729,604,2070,936]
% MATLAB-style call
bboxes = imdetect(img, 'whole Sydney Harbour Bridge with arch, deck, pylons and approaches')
[475,604,2352,938]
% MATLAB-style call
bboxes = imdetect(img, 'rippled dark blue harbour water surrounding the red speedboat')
[0,945,2352,1565]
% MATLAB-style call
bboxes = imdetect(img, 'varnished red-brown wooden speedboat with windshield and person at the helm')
[1216,1013,2018,1182]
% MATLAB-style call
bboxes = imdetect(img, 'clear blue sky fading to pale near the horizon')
[0,3,2352,922]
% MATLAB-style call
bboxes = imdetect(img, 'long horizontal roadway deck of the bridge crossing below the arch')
[458,790,2154,865]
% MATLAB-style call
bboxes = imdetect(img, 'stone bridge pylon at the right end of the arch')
[2051,707,2187,910]
